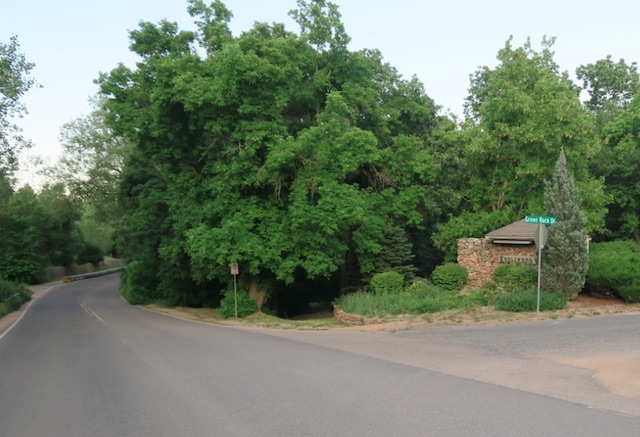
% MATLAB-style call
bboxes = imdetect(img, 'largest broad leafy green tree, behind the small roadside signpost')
[100,0,439,304]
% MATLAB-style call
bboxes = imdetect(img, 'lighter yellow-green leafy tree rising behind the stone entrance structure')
[464,39,605,229]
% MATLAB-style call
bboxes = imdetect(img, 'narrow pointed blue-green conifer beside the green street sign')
[542,150,589,299]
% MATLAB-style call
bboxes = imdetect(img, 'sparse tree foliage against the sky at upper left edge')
[0,36,36,176]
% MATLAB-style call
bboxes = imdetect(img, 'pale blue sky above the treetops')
[0,0,640,179]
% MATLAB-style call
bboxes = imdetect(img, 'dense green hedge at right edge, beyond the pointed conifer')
[586,241,640,302]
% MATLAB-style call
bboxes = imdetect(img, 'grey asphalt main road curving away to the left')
[0,276,640,437]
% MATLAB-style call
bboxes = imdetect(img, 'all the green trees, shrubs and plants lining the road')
[0,0,640,320]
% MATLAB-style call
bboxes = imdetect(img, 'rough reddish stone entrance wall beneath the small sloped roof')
[458,238,537,288]
